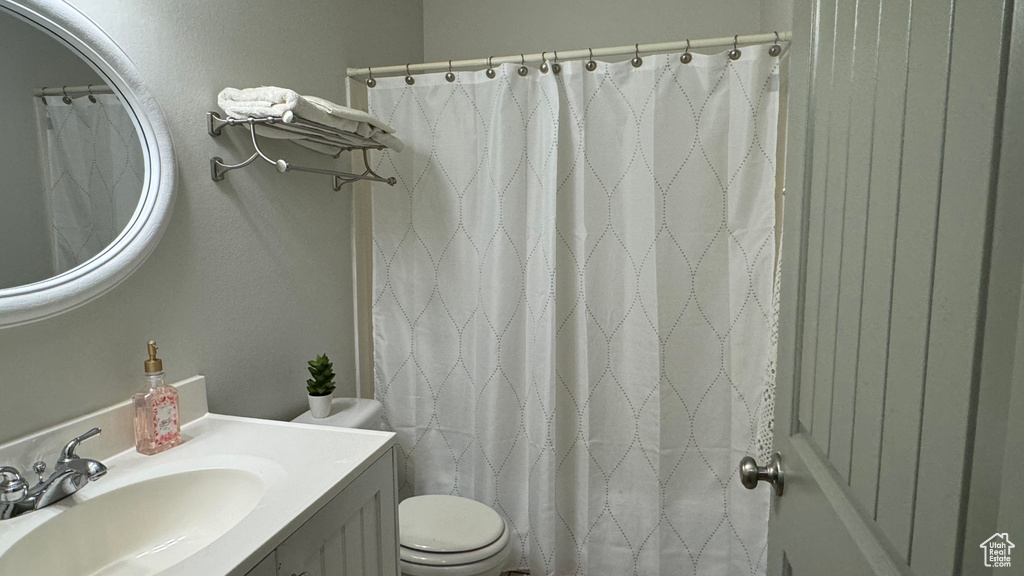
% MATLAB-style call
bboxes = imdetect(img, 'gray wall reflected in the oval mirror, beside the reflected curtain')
[0,11,100,288]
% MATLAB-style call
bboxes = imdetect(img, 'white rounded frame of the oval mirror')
[0,0,175,328]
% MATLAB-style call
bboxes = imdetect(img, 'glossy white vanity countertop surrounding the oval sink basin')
[0,377,394,576]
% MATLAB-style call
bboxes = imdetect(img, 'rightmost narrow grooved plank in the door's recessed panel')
[877,2,950,560]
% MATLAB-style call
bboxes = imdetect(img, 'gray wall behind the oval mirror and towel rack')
[0,0,423,442]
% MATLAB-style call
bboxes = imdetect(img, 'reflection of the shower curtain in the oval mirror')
[37,94,145,274]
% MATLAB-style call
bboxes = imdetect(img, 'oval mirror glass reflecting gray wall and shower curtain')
[0,10,145,289]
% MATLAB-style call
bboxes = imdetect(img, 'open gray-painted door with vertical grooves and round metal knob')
[757,0,1024,576]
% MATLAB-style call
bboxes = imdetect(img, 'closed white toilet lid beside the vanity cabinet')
[398,495,505,552]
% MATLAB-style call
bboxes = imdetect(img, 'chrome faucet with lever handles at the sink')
[0,428,106,520]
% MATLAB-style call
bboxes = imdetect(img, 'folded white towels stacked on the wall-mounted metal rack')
[217,86,404,155]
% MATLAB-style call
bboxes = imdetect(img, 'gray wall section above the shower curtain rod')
[423,0,793,64]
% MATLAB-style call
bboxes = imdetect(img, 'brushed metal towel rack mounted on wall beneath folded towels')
[206,111,397,191]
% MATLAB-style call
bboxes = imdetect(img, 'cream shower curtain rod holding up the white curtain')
[345,32,793,78]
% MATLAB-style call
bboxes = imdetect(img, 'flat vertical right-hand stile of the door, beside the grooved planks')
[910,2,1019,574]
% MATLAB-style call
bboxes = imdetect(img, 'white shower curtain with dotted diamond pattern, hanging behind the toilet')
[369,47,779,576]
